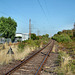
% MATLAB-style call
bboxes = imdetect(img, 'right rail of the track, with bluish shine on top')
[35,41,54,75]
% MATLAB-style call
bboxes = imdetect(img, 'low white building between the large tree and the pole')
[15,33,29,42]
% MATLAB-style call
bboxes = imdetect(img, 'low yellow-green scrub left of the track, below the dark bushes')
[18,38,49,52]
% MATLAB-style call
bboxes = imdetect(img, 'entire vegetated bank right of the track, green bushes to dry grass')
[52,30,75,75]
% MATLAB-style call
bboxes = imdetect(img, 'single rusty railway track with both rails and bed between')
[4,40,54,75]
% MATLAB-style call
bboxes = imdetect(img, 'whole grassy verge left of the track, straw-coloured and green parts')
[0,40,48,65]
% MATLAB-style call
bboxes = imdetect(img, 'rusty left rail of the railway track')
[3,40,52,75]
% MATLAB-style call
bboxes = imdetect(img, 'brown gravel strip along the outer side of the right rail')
[40,44,58,75]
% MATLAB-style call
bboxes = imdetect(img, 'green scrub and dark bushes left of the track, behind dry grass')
[18,34,49,52]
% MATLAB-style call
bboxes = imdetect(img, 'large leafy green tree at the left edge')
[0,17,17,41]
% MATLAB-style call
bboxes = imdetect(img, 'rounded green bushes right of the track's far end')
[52,30,73,43]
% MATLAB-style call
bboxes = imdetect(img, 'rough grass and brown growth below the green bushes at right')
[56,40,75,75]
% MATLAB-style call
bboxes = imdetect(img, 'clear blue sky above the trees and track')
[0,0,75,36]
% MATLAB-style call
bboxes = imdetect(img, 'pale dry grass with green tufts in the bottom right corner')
[56,51,75,75]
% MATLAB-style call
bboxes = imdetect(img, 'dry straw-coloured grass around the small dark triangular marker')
[0,45,42,65]
